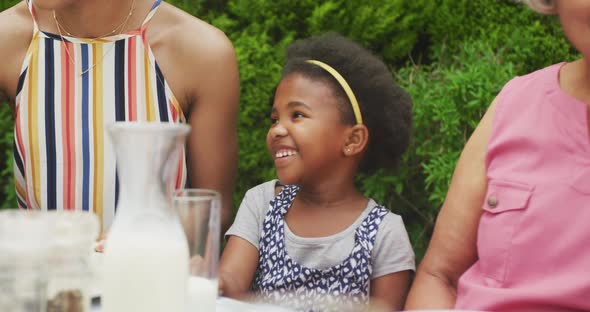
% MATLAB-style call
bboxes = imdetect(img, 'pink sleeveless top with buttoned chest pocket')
[456,63,590,311]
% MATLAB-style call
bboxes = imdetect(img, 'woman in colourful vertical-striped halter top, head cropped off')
[0,0,239,234]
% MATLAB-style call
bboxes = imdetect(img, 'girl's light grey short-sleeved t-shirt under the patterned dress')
[225,180,416,279]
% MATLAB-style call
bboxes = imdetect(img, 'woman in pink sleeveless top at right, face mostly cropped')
[407,0,590,311]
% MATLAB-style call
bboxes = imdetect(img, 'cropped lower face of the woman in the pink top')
[555,0,590,58]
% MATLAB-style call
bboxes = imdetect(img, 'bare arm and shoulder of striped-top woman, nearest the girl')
[162,12,240,233]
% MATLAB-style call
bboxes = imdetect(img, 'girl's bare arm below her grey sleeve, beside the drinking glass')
[219,236,258,300]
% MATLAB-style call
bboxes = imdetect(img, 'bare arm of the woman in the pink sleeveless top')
[406,101,495,310]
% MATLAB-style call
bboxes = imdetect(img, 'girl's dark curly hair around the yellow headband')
[283,33,412,174]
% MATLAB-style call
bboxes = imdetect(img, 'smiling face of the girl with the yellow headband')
[266,74,351,185]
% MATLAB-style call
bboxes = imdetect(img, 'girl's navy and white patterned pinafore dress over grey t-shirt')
[253,185,389,311]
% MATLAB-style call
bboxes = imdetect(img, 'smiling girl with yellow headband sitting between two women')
[220,34,414,311]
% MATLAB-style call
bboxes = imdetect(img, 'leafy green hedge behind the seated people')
[0,0,577,259]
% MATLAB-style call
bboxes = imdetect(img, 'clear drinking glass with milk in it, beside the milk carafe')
[173,189,221,311]
